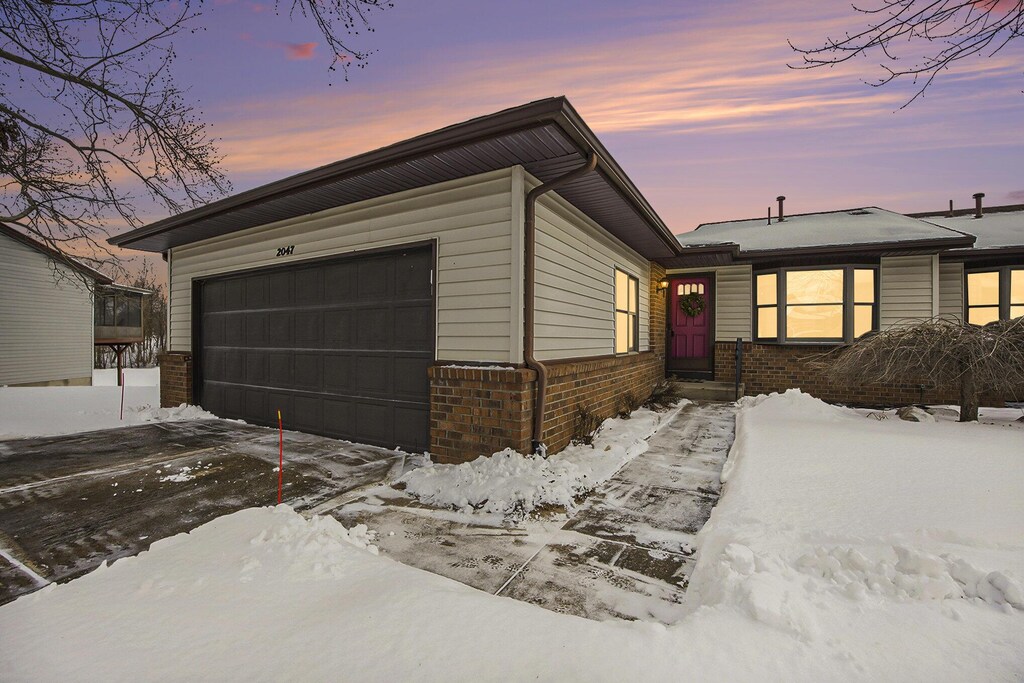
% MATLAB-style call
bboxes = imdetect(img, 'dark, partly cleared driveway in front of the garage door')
[0,420,406,604]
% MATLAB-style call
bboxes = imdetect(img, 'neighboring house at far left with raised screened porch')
[0,223,149,386]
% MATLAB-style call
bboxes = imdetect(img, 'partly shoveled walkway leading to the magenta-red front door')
[331,403,736,624]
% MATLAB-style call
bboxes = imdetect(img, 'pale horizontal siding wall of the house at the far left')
[0,236,92,385]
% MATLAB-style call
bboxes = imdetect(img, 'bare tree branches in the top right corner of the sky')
[790,0,1024,109]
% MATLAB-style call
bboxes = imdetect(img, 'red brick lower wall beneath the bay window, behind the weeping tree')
[715,342,1002,405]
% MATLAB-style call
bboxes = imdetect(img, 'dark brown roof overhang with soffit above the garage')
[109,97,680,258]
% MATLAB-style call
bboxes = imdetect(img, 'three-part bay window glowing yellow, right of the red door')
[754,266,878,342]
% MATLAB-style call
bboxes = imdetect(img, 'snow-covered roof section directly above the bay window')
[677,207,964,252]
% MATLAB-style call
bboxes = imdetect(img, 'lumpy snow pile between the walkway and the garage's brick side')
[398,400,689,523]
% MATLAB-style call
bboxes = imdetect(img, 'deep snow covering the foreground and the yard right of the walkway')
[0,392,1024,681]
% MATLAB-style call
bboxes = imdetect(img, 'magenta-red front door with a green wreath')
[667,276,712,372]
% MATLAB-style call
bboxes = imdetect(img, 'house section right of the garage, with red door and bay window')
[666,198,1024,404]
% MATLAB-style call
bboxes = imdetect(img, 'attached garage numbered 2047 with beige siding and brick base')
[112,97,678,462]
